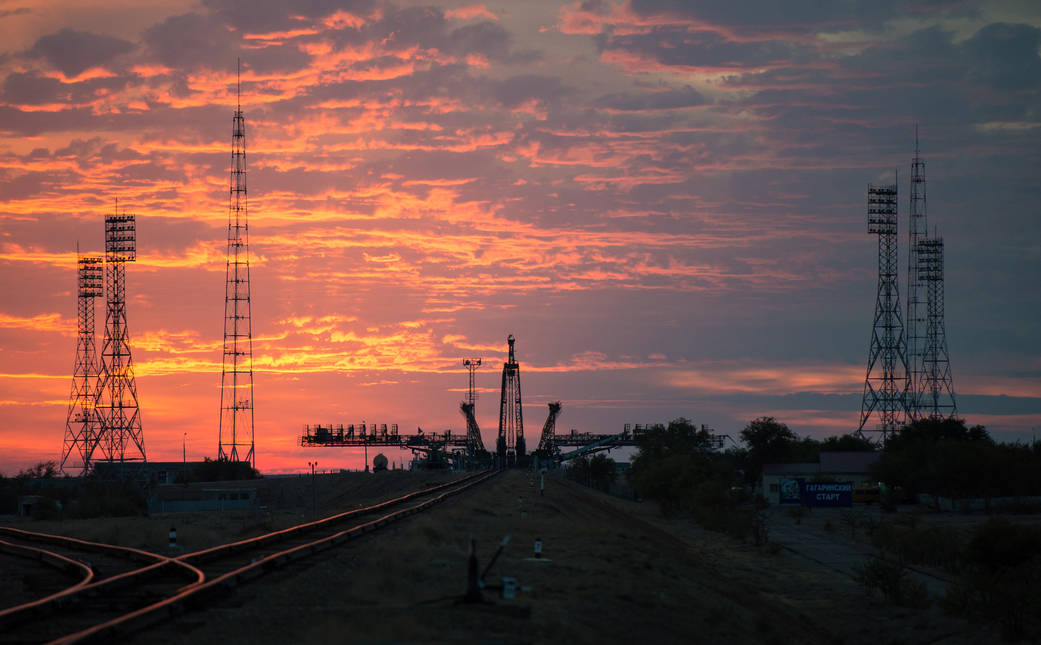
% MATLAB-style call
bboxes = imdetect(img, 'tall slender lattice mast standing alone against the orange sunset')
[218,65,256,468]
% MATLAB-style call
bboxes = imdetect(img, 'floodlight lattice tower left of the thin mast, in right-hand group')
[857,184,908,442]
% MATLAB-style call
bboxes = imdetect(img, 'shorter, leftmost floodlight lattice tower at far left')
[59,256,105,475]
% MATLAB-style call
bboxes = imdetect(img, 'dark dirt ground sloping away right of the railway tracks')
[113,472,998,645]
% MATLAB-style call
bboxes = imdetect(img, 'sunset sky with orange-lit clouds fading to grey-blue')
[0,0,1041,475]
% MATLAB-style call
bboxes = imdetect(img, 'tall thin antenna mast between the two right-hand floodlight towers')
[906,124,929,420]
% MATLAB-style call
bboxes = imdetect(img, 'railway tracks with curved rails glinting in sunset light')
[0,471,496,644]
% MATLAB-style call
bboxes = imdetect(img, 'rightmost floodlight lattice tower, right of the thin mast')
[917,236,958,418]
